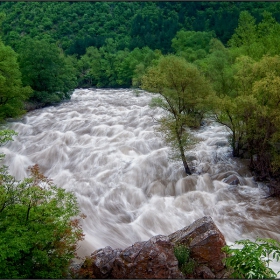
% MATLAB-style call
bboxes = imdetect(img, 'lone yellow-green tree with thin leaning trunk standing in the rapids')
[141,55,212,174]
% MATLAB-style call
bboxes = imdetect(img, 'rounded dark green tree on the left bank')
[19,39,76,105]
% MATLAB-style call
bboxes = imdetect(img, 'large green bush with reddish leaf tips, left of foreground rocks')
[0,165,83,279]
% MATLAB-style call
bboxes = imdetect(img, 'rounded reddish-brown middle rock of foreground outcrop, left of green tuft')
[112,235,183,279]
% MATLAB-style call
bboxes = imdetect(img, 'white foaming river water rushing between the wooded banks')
[1,89,280,269]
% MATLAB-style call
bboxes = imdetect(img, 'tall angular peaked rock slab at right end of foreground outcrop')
[169,216,226,273]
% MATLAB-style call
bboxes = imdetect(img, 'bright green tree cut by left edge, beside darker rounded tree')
[0,41,32,121]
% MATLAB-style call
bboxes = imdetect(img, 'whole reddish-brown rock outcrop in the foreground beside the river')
[75,216,228,279]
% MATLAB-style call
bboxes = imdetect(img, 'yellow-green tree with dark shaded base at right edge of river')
[211,53,280,185]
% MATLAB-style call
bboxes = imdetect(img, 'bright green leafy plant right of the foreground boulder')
[223,238,280,279]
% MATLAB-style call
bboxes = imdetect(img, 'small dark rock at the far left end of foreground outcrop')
[79,246,122,279]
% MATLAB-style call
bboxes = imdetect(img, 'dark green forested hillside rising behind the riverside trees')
[0,1,280,55]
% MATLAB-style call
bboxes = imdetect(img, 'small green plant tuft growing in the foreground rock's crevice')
[174,244,196,275]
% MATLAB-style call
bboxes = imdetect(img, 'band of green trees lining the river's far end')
[77,45,161,87]
